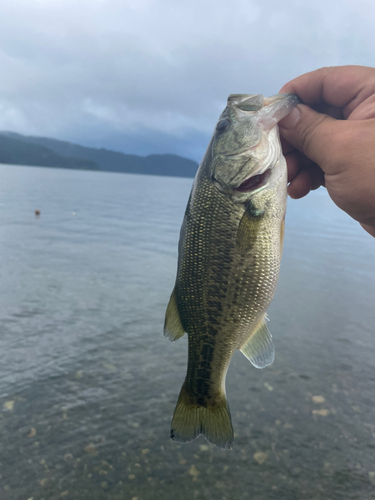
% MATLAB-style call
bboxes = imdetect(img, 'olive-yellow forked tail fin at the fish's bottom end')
[171,384,233,450]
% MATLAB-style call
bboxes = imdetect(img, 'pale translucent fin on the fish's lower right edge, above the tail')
[240,316,275,368]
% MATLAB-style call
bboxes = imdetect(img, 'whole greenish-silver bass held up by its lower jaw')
[164,94,299,449]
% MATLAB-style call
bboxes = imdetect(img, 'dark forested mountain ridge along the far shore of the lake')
[0,132,198,177]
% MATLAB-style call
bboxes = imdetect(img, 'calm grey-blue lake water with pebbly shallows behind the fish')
[0,166,375,500]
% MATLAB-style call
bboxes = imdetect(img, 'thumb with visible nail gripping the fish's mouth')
[279,104,337,166]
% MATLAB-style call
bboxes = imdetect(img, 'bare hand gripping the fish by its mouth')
[279,66,375,237]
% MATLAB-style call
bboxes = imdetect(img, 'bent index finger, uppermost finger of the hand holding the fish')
[280,66,375,114]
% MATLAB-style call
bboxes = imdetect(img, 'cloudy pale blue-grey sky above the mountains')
[0,0,375,161]
